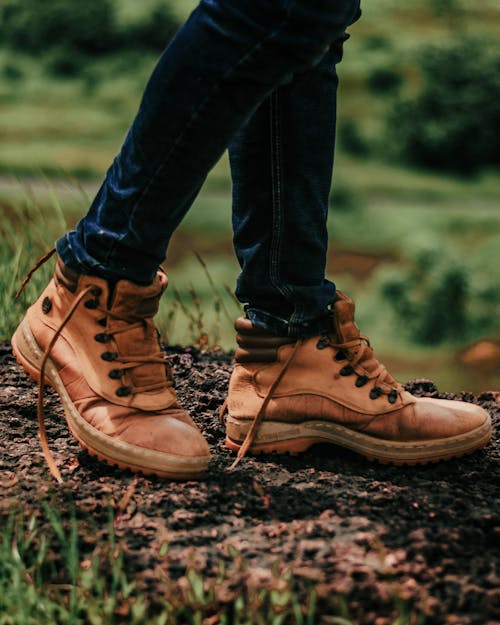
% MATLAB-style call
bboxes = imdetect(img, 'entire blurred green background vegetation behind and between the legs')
[0,0,500,390]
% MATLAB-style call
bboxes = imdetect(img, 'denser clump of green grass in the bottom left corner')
[0,505,157,625]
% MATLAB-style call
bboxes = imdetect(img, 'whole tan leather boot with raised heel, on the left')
[12,260,210,479]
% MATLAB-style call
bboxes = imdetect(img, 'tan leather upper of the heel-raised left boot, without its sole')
[27,261,209,456]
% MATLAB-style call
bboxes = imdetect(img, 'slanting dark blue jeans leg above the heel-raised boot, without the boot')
[57,0,359,283]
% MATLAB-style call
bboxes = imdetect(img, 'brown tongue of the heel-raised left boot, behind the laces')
[108,272,168,387]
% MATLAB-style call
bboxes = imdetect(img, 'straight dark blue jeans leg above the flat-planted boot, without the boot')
[229,37,345,336]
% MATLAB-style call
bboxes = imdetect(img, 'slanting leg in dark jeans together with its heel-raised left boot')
[12,0,364,479]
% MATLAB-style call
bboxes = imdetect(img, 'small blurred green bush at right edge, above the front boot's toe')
[377,238,500,344]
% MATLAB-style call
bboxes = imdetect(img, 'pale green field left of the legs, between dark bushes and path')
[0,51,154,177]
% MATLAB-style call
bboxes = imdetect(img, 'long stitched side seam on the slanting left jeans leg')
[107,13,289,262]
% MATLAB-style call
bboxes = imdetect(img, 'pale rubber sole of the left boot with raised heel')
[11,319,210,480]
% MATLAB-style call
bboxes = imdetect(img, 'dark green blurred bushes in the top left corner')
[0,0,178,75]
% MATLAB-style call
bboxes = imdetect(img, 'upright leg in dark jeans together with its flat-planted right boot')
[226,9,491,464]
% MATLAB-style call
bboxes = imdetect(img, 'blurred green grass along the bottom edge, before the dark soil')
[0,504,424,625]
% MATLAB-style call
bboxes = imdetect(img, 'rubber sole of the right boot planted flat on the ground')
[226,415,492,465]
